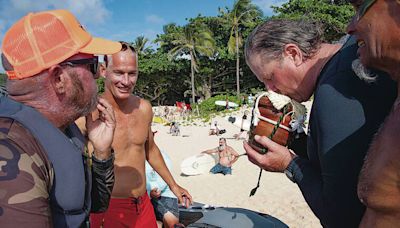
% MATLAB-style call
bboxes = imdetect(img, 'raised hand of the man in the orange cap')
[86,98,116,160]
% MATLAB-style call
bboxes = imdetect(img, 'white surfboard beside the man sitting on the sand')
[181,154,218,176]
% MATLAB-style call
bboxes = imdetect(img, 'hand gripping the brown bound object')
[243,135,296,172]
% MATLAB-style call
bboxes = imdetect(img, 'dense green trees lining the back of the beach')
[124,0,353,106]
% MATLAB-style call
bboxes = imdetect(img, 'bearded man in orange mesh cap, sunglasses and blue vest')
[0,10,121,227]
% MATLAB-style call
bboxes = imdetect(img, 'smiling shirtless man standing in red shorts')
[85,42,192,228]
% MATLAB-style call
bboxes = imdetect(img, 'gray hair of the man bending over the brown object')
[245,19,323,62]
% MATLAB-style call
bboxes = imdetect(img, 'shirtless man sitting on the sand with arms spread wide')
[201,138,239,175]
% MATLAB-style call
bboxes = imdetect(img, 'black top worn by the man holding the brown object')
[293,39,397,228]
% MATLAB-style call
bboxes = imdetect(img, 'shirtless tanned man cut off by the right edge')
[348,0,400,227]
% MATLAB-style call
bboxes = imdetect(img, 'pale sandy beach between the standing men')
[152,109,321,227]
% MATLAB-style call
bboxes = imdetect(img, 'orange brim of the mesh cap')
[79,37,122,55]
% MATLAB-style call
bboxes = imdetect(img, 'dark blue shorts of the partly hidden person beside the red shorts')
[151,196,179,221]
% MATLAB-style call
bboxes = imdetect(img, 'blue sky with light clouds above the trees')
[0,0,287,72]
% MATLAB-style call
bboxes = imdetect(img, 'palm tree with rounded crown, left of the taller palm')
[168,23,215,103]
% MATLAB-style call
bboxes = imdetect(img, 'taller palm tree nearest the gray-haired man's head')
[225,0,262,97]
